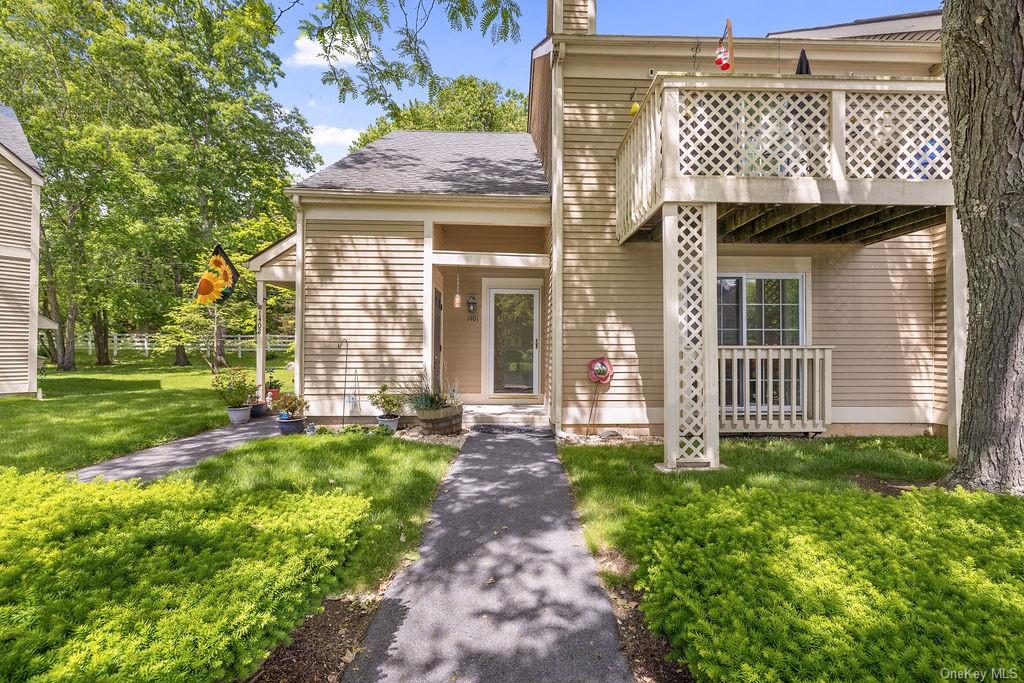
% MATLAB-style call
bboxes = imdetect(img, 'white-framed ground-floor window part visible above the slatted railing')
[718,273,804,346]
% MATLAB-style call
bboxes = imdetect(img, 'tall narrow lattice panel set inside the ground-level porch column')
[676,205,708,459]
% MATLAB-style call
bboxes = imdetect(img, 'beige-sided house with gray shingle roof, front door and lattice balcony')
[243,0,966,466]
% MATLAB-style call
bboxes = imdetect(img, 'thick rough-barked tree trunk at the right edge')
[943,0,1024,495]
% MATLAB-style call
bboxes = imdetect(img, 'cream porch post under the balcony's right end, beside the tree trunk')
[946,207,968,460]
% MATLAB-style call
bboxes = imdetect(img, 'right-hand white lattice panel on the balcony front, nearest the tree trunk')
[846,92,952,180]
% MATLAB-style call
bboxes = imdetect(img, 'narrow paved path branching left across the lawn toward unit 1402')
[72,417,279,481]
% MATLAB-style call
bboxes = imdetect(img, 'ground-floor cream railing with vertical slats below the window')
[718,346,831,434]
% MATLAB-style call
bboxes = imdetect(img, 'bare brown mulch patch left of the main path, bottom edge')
[249,596,380,683]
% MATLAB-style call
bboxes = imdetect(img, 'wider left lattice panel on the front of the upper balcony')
[679,90,830,178]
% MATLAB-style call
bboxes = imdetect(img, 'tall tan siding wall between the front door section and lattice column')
[561,78,664,423]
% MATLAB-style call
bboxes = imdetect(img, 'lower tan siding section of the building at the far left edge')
[0,256,32,394]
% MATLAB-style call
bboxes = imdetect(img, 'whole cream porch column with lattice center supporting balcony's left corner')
[662,204,719,470]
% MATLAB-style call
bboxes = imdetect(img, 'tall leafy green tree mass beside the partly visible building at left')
[0,0,315,370]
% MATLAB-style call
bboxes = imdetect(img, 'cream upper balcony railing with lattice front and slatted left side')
[615,75,952,241]
